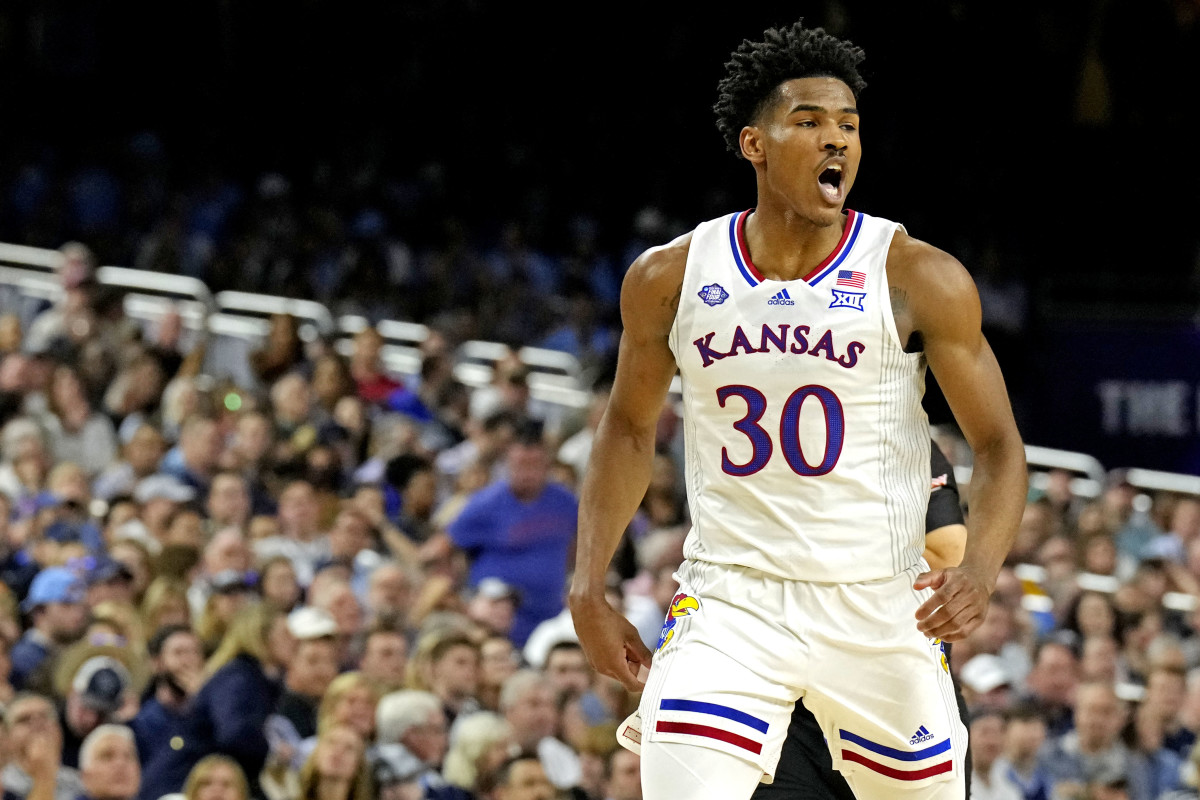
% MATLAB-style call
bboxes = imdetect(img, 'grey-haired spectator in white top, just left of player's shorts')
[499,669,582,789]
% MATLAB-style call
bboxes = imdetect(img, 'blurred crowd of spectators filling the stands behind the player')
[0,250,1200,800]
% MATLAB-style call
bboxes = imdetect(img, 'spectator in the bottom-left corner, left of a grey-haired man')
[0,693,84,800]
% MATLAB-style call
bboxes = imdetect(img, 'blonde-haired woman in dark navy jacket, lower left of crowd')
[142,603,295,798]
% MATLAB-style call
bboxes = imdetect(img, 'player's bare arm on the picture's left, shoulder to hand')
[568,234,691,692]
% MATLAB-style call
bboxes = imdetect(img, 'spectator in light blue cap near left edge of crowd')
[10,566,88,688]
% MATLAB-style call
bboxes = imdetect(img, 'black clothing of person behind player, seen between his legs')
[751,443,971,800]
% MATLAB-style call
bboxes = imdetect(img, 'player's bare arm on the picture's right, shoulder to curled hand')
[888,236,1028,642]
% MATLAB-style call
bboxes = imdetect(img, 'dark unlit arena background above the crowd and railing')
[0,0,1200,470]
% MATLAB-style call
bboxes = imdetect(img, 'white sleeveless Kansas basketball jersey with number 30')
[670,211,930,583]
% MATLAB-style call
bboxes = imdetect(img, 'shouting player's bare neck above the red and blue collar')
[745,206,846,281]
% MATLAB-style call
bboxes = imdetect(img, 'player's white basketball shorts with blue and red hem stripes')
[638,561,967,796]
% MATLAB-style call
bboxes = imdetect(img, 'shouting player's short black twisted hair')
[713,19,866,155]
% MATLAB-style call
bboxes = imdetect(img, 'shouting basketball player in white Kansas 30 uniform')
[569,17,1027,800]
